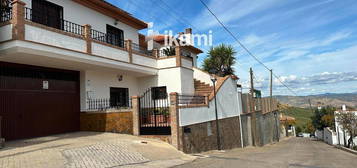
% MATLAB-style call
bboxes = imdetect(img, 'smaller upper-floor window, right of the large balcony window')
[107,25,124,47]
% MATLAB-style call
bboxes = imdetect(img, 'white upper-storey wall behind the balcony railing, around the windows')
[23,0,139,44]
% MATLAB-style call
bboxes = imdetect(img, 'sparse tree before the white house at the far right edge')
[337,112,357,148]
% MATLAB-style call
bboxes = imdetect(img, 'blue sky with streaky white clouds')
[107,0,357,96]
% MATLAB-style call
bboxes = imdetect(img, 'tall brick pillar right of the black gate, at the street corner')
[170,92,183,151]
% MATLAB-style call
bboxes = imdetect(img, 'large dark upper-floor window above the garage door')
[32,0,63,29]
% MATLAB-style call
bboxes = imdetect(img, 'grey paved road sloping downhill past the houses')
[177,138,357,168]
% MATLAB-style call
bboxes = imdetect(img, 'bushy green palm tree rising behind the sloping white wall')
[203,44,236,77]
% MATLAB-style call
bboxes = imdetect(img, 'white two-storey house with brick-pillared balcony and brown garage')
[0,0,210,139]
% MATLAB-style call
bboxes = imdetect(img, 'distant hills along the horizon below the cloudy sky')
[275,92,357,108]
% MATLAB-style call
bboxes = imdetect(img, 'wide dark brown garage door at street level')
[0,62,80,140]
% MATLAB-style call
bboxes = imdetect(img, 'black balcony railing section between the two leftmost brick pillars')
[25,7,84,36]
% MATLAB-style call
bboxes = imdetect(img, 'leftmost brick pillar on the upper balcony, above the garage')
[11,0,26,40]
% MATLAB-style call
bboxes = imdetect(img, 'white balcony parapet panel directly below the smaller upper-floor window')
[92,42,129,62]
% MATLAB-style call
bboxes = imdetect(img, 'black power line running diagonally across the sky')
[199,0,298,96]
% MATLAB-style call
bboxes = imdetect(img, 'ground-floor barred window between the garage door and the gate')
[110,87,129,107]
